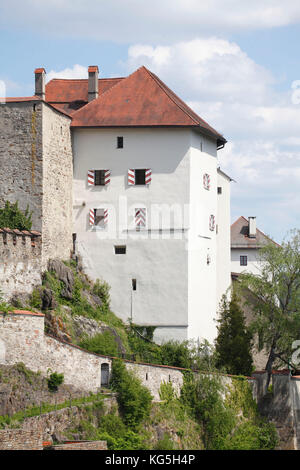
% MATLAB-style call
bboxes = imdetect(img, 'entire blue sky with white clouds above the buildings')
[0,0,300,242]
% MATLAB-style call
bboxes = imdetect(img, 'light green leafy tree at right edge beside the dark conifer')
[239,230,300,385]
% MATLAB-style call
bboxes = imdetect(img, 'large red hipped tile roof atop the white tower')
[71,67,226,144]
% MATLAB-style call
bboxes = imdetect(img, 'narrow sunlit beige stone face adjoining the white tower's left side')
[42,104,73,269]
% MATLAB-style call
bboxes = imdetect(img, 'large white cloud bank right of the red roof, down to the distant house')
[125,37,300,241]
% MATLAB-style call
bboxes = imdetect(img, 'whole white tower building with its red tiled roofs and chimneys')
[0,66,231,342]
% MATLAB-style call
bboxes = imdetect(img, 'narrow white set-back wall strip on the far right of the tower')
[217,172,231,307]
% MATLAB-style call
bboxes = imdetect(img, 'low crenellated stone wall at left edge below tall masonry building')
[0,229,42,300]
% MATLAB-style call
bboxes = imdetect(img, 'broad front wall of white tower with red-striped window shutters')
[73,129,190,341]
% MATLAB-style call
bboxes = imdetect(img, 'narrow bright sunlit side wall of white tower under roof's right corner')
[188,133,217,341]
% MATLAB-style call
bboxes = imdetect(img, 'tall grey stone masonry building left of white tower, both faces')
[0,99,73,269]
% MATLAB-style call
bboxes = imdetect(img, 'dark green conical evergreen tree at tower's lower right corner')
[215,294,252,375]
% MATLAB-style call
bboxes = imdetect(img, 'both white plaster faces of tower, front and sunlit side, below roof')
[73,128,223,342]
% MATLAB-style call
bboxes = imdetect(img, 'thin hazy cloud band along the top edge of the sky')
[0,0,300,44]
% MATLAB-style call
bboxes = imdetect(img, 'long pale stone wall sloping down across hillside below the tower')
[0,311,255,401]
